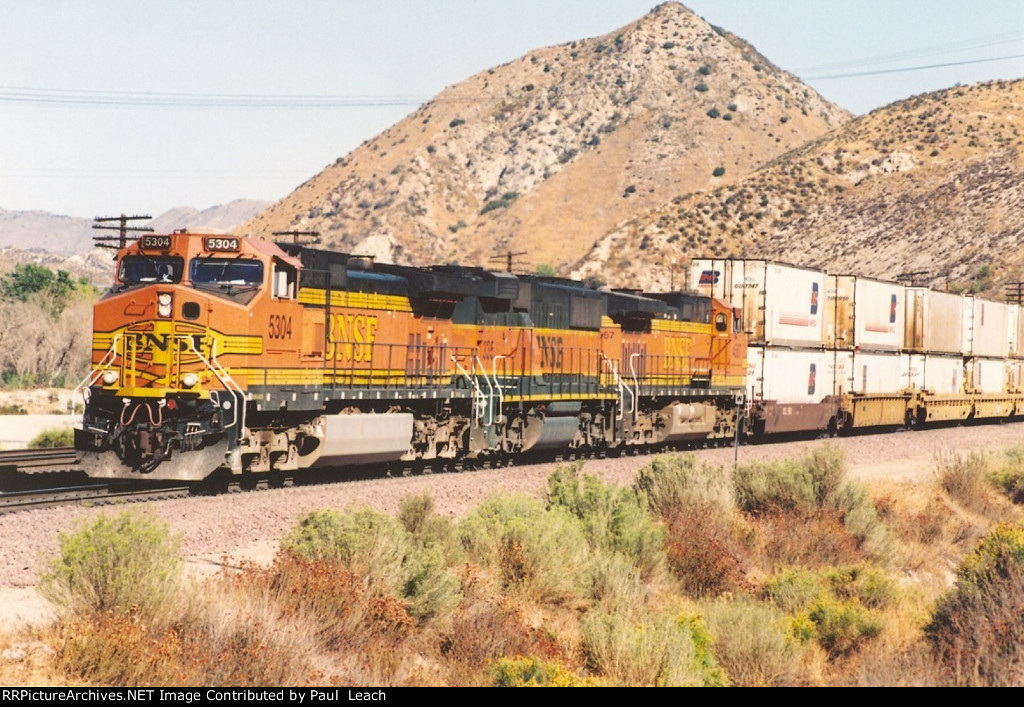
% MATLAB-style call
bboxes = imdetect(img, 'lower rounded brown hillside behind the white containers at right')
[574,81,1024,296]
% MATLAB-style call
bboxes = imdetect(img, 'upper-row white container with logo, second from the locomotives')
[825,275,906,351]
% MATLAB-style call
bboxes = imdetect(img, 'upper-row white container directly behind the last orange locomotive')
[690,258,826,347]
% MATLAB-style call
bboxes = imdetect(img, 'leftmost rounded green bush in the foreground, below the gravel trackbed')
[39,512,181,617]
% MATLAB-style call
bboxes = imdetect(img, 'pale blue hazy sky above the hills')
[0,0,1024,218]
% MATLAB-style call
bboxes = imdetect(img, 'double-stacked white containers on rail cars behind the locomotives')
[690,258,1024,433]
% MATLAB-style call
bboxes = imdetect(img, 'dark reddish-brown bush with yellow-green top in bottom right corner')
[925,525,1024,685]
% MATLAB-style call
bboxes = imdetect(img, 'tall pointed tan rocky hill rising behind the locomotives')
[243,2,850,272]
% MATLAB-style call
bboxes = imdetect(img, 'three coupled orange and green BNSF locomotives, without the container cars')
[75,231,748,482]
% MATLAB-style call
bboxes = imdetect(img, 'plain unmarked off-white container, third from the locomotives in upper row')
[903,287,964,355]
